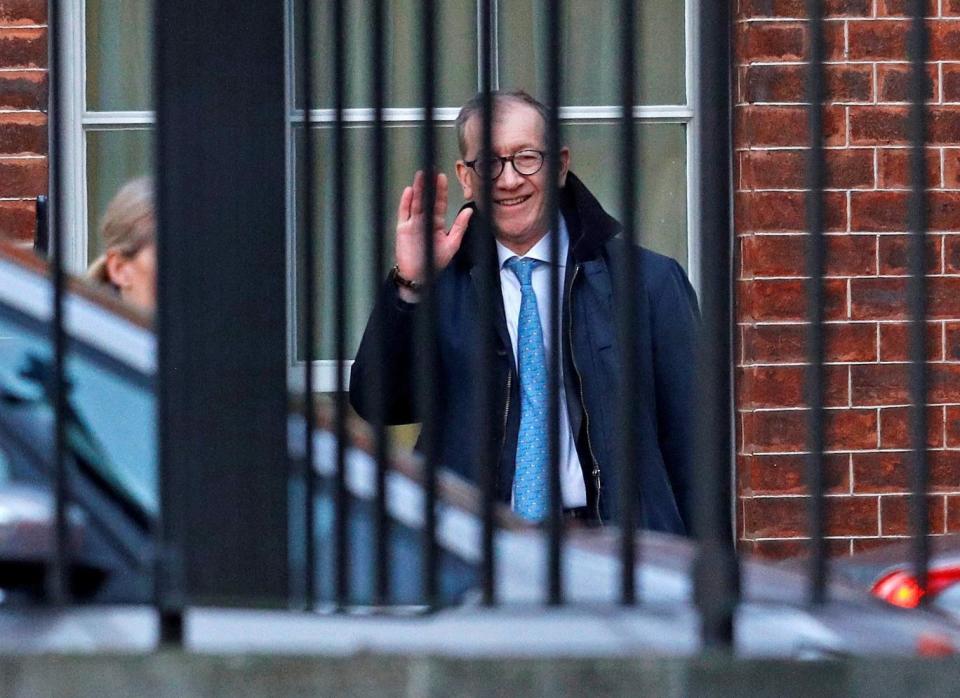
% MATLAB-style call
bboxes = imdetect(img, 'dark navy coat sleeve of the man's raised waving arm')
[350,278,418,424]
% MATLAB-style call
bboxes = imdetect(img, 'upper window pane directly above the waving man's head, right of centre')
[499,0,686,106]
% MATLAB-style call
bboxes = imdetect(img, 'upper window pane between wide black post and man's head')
[297,0,477,108]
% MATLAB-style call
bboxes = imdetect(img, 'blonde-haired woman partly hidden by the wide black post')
[87,177,157,312]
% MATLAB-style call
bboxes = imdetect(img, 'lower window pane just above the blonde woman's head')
[87,129,153,263]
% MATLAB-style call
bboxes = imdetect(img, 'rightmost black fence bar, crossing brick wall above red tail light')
[908,0,930,601]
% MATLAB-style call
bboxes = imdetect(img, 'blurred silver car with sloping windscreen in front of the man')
[0,241,960,658]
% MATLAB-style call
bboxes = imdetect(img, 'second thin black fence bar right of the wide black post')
[333,0,350,609]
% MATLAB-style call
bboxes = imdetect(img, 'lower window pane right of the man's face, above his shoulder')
[563,123,687,268]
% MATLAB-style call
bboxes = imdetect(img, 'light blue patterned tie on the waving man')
[507,257,548,521]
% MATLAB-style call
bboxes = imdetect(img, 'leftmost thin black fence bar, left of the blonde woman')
[46,0,70,604]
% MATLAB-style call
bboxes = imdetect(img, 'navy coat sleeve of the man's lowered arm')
[650,259,700,531]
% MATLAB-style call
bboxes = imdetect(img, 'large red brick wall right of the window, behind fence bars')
[734,0,960,556]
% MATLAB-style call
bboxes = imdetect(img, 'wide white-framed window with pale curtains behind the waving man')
[58,0,696,391]
